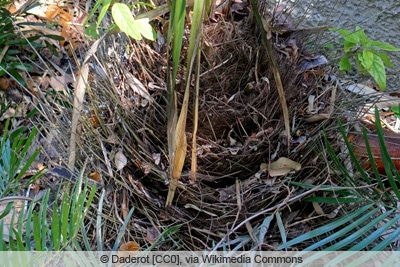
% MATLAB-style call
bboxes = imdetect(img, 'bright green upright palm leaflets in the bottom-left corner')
[0,180,96,251]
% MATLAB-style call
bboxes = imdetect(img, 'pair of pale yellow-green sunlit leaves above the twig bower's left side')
[111,3,155,40]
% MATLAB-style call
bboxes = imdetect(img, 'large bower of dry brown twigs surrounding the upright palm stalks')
[63,4,344,250]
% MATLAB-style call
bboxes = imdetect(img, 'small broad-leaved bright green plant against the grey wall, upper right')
[330,26,400,90]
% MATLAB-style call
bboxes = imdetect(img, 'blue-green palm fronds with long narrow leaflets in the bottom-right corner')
[278,109,400,251]
